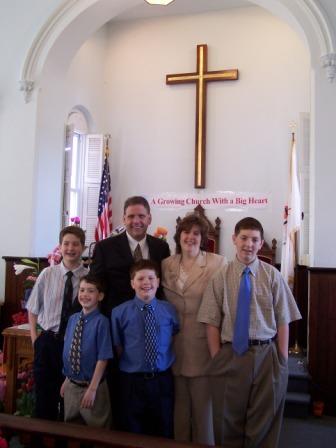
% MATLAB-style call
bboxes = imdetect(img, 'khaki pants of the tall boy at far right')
[209,342,288,448]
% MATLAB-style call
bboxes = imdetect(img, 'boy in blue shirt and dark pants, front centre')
[112,260,179,438]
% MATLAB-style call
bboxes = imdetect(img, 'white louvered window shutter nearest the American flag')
[82,134,104,246]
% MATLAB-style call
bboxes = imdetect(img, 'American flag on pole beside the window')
[95,156,112,241]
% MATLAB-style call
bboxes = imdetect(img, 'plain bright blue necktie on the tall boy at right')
[232,268,251,355]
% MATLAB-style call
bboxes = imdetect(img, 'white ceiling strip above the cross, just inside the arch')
[113,0,253,21]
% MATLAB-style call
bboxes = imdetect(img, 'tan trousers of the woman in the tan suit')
[174,376,214,445]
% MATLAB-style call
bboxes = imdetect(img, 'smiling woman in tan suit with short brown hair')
[162,214,224,445]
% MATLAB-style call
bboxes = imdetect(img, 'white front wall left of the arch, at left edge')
[0,0,60,300]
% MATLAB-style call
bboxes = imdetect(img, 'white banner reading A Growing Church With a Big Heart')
[146,191,270,211]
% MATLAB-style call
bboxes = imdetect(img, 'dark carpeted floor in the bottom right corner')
[279,416,336,448]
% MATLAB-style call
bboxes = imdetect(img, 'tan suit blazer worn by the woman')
[162,252,225,377]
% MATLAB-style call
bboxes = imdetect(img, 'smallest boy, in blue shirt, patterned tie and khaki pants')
[60,274,113,427]
